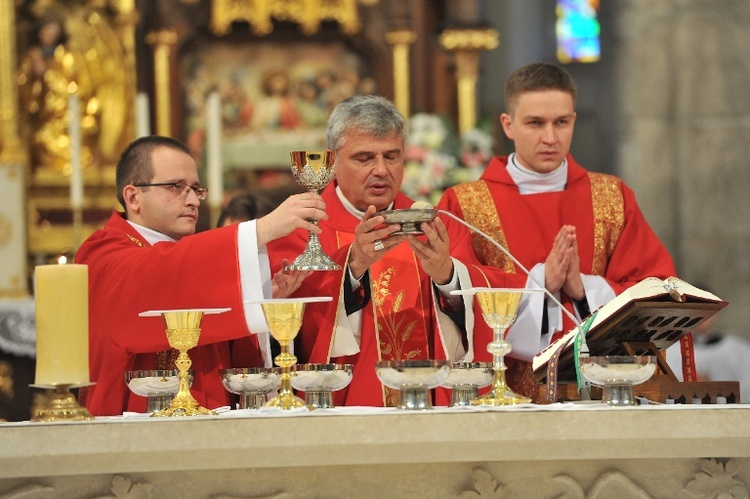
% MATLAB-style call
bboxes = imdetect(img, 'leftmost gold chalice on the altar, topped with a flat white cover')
[138,308,229,417]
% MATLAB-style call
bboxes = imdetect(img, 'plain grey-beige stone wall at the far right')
[611,0,750,337]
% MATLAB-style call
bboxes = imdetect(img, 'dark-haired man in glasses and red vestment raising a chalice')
[76,136,327,415]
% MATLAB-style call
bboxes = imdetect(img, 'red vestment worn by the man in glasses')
[76,213,260,416]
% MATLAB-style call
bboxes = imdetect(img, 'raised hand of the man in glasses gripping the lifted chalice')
[256,192,328,248]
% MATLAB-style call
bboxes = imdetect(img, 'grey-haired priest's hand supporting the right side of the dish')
[407,218,453,284]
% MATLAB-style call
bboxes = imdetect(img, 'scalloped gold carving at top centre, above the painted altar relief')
[212,0,361,36]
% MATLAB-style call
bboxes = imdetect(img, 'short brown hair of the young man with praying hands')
[505,62,578,116]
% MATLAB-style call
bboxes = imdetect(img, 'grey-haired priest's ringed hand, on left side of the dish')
[349,205,406,279]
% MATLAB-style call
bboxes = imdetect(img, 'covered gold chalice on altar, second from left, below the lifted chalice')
[255,296,333,410]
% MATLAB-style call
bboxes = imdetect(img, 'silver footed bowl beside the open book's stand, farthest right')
[581,355,656,406]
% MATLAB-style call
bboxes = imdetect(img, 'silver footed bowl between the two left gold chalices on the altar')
[219,367,281,409]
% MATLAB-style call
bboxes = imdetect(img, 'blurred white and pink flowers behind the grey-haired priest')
[401,113,493,205]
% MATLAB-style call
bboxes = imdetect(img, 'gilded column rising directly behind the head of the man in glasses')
[146,29,177,137]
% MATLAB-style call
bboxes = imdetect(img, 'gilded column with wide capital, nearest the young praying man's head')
[440,28,499,133]
